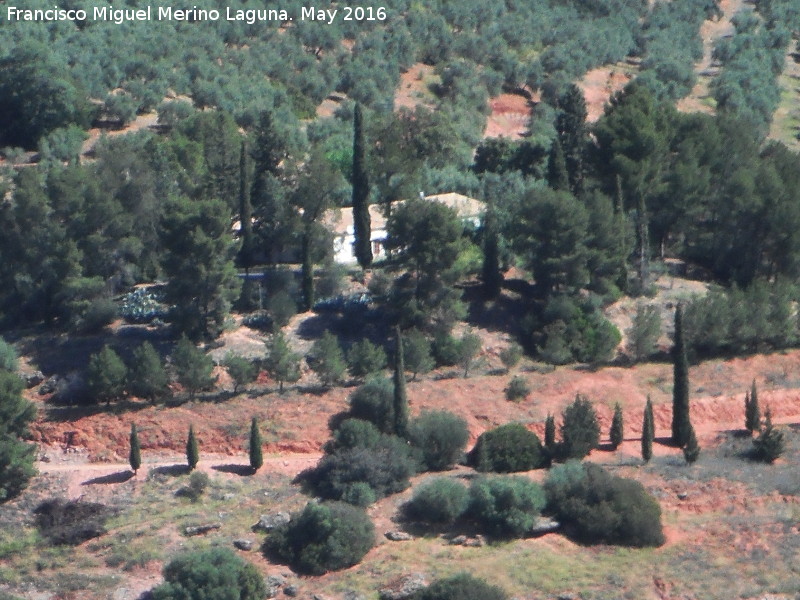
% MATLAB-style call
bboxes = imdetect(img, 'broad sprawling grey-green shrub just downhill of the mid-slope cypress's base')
[300,435,417,500]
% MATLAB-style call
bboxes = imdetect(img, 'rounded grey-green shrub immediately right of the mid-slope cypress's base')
[409,410,469,471]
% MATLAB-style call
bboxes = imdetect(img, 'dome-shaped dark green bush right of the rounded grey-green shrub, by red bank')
[469,423,546,473]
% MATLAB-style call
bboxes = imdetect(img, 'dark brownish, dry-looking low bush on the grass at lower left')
[33,499,114,546]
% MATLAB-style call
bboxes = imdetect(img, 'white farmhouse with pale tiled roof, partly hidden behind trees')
[325,192,486,265]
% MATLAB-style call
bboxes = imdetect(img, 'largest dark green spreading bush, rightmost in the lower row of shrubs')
[545,461,664,547]
